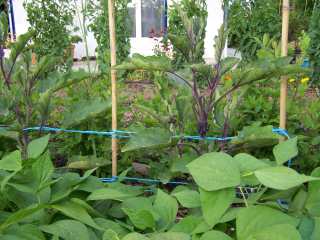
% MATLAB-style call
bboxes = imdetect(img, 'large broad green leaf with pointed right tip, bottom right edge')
[236,206,299,240]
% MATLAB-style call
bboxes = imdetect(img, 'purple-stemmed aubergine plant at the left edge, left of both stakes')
[0,13,92,158]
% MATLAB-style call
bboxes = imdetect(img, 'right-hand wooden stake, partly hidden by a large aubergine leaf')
[280,0,290,133]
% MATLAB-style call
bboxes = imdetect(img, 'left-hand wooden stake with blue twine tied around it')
[108,0,118,176]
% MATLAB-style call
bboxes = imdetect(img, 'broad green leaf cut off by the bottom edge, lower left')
[39,220,90,240]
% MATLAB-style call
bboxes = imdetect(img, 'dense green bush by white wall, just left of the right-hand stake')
[228,0,281,60]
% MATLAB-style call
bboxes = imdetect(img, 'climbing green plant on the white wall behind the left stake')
[86,0,131,72]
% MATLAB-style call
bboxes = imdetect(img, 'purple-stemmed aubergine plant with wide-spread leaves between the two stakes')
[116,10,305,141]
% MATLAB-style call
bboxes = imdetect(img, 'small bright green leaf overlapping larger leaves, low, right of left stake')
[122,208,155,230]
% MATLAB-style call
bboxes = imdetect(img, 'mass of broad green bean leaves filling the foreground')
[0,130,320,240]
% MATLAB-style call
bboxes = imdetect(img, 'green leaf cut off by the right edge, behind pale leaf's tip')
[306,168,320,217]
